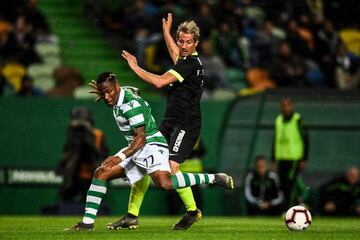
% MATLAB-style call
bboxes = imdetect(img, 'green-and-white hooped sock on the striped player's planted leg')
[83,178,106,224]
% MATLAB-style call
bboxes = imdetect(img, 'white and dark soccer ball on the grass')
[285,206,312,231]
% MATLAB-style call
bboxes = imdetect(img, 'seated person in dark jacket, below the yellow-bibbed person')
[245,155,284,215]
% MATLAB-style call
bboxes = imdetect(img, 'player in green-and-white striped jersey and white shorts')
[66,72,234,231]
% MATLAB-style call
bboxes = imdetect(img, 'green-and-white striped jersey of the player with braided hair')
[113,88,167,145]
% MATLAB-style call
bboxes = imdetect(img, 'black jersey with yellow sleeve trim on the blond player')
[163,52,204,127]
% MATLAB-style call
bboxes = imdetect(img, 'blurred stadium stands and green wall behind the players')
[0,0,360,218]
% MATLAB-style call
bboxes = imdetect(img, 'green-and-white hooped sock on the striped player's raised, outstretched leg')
[171,173,215,189]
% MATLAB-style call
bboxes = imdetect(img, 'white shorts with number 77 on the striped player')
[120,143,171,184]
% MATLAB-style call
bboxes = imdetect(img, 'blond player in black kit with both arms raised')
[108,13,233,230]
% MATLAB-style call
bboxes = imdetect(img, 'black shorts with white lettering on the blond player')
[159,121,200,164]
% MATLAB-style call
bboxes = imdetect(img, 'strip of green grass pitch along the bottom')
[0,216,360,240]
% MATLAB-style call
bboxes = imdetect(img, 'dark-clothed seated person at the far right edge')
[319,167,360,216]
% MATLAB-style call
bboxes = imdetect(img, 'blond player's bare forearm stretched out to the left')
[121,50,177,88]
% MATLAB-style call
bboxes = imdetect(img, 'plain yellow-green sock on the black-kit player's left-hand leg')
[128,176,150,216]
